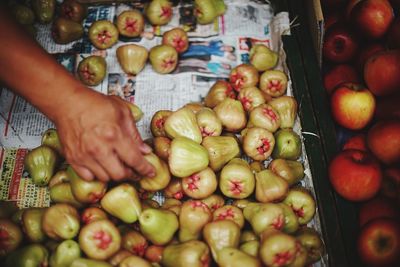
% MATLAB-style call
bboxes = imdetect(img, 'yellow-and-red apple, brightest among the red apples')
[331,83,375,130]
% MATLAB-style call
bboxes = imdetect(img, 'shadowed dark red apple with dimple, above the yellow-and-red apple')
[322,24,359,63]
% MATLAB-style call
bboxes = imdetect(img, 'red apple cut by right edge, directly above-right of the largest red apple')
[367,120,400,165]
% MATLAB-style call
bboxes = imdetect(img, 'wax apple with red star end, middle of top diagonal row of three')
[117,9,144,37]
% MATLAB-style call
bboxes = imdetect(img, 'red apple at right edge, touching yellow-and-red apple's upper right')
[364,50,400,96]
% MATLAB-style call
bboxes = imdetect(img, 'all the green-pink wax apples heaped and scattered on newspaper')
[0,0,328,267]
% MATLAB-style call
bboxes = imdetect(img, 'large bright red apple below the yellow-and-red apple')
[329,149,382,201]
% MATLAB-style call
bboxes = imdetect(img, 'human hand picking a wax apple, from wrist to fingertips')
[54,89,155,182]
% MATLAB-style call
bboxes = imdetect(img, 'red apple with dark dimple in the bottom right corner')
[357,218,400,267]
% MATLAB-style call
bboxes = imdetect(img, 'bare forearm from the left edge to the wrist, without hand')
[0,5,88,121]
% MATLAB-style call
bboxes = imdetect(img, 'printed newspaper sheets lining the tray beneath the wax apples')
[0,0,326,266]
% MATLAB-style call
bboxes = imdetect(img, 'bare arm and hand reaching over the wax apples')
[0,4,155,181]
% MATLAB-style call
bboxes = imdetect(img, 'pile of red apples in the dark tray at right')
[321,0,400,266]
